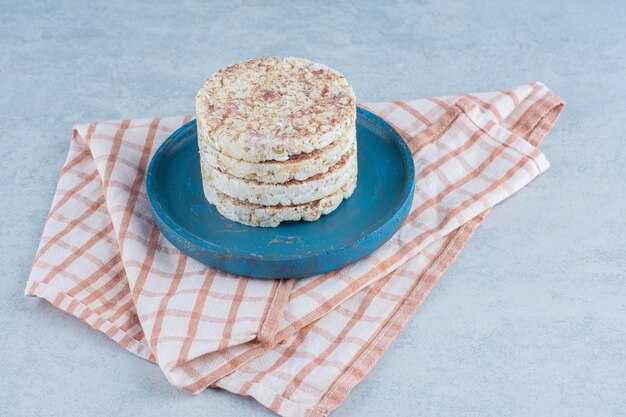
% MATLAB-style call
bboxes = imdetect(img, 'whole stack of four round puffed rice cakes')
[196,57,357,227]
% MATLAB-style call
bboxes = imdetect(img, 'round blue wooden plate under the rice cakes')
[146,108,415,278]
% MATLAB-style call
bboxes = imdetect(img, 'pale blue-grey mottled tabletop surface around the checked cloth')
[0,0,626,417]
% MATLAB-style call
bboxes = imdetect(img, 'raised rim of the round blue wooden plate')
[146,106,415,263]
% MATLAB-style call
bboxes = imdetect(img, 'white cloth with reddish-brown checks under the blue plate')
[26,83,564,416]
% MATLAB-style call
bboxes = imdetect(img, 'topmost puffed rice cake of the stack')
[196,57,356,162]
